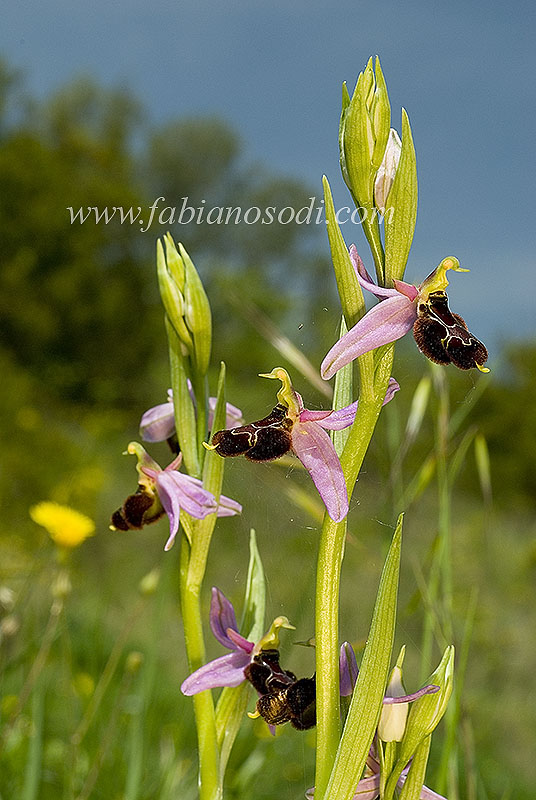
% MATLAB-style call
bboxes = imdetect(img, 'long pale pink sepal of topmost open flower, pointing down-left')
[320,292,417,380]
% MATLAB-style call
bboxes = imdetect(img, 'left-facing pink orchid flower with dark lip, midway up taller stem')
[205,367,400,522]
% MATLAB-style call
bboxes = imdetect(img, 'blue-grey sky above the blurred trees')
[0,0,536,344]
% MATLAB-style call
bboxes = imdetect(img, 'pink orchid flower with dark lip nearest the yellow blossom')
[110,442,242,550]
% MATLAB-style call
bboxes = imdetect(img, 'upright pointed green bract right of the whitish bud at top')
[385,109,417,286]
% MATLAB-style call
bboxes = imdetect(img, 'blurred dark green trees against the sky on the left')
[0,61,331,407]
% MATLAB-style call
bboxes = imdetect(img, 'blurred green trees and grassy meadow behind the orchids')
[0,59,536,800]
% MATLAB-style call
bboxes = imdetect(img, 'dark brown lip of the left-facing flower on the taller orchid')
[211,404,292,461]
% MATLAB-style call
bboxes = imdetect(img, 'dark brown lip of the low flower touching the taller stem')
[244,649,316,731]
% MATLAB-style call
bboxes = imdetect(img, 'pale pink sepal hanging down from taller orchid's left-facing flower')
[292,420,348,522]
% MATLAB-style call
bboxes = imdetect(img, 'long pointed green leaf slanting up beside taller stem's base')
[325,514,403,800]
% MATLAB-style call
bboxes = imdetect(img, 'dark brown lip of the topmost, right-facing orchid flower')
[413,292,488,369]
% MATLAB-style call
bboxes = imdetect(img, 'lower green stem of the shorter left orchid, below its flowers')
[180,534,222,800]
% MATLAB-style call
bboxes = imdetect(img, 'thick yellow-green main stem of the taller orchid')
[315,348,393,800]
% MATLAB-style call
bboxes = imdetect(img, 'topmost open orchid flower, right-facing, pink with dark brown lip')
[320,245,489,380]
